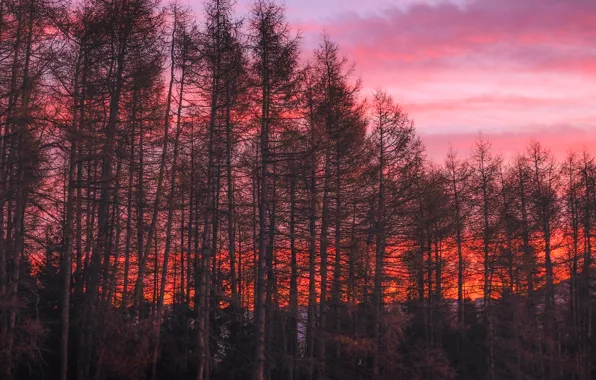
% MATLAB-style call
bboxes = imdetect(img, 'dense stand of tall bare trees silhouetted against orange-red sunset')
[0,0,596,380]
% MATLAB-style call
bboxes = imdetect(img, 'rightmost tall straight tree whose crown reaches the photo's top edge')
[249,1,298,380]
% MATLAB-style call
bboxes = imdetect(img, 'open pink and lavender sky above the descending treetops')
[214,0,596,160]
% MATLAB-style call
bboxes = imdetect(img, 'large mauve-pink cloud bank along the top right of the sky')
[311,0,596,67]
